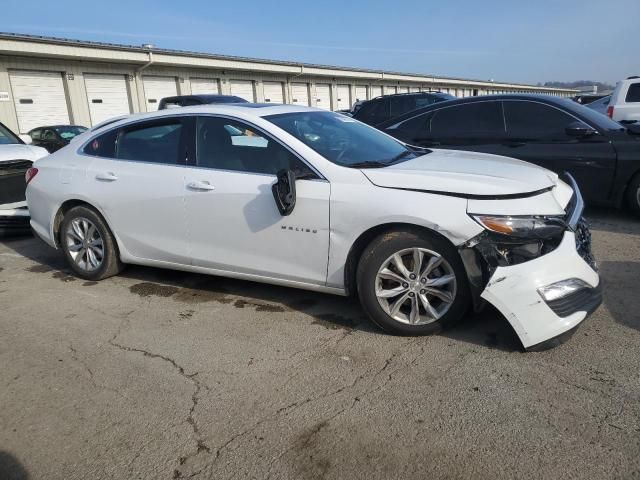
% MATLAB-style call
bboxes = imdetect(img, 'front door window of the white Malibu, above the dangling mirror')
[196,117,315,178]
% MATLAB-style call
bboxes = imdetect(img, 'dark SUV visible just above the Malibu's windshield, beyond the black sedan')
[351,92,456,127]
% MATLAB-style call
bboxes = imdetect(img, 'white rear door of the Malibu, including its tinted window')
[84,117,190,265]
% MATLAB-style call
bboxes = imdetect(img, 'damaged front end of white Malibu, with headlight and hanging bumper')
[459,172,602,349]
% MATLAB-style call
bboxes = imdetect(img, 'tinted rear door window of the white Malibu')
[116,120,182,165]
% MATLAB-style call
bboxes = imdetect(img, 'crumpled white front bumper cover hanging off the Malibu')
[481,231,602,349]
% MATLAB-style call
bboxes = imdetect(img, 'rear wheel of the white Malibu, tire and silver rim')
[59,206,123,281]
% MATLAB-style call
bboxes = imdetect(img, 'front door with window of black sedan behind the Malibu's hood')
[503,100,616,202]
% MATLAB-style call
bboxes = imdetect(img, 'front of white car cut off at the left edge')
[0,123,48,236]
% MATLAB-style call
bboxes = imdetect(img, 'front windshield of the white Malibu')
[265,111,426,168]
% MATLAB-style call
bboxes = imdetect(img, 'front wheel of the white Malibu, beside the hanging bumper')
[356,230,471,335]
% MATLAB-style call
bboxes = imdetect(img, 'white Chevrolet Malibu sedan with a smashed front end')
[27,104,601,348]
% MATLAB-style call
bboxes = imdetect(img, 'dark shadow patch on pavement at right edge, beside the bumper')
[599,261,640,330]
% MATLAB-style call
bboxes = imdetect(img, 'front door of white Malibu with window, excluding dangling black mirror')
[181,116,330,284]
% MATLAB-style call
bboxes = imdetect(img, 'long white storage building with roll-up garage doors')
[0,34,576,133]
